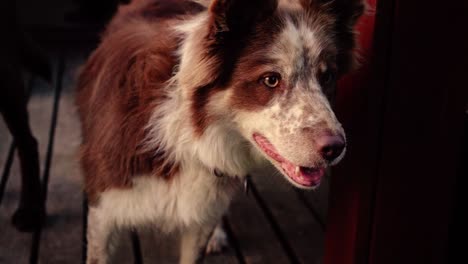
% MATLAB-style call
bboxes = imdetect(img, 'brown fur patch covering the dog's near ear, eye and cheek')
[192,6,283,135]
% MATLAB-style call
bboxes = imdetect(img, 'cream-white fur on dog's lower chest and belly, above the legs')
[98,166,240,232]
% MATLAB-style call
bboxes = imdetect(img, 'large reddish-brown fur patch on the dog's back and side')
[77,1,203,201]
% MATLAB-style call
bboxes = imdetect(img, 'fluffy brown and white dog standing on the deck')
[77,0,364,263]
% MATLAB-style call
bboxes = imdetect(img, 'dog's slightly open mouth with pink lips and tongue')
[253,133,325,188]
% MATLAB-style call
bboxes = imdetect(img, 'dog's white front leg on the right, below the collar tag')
[179,225,215,264]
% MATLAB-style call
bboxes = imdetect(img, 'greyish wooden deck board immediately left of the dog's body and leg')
[39,53,84,264]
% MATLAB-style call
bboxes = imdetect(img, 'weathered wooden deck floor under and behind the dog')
[0,0,328,264]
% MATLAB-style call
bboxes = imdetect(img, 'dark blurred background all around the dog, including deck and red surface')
[0,0,468,264]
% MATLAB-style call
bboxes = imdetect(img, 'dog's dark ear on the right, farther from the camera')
[301,0,367,74]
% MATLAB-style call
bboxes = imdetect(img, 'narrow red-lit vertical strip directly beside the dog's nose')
[325,0,377,264]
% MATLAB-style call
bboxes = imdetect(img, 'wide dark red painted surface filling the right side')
[324,0,468,264]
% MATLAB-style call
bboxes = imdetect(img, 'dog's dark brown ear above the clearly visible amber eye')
[209,0,278,38]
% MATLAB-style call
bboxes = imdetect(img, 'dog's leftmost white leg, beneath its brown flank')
[86,207,114,264]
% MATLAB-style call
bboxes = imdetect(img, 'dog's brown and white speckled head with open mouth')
[177,0,364,188]
